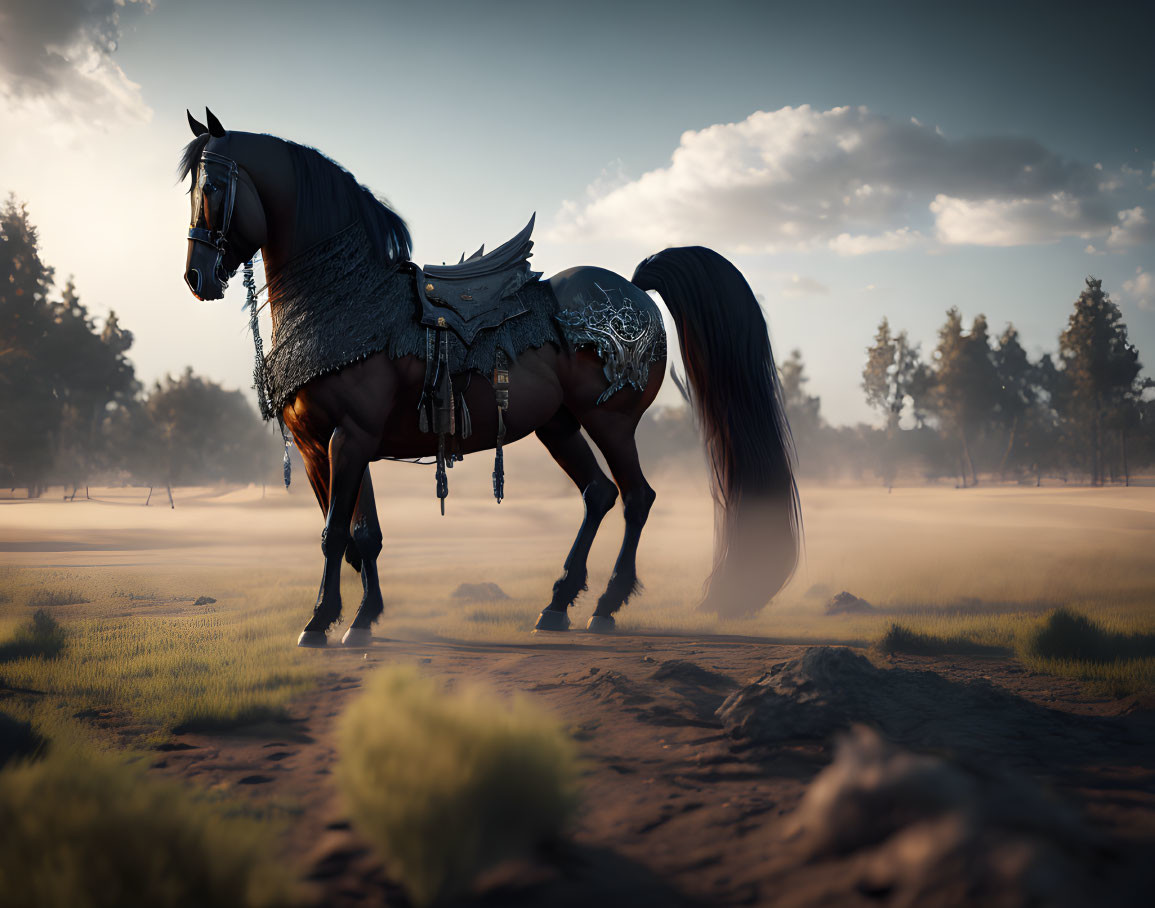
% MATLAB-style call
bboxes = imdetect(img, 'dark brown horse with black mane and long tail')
[178,111,802,647]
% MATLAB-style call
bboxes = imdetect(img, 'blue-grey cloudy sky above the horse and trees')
[0,0,1155,424]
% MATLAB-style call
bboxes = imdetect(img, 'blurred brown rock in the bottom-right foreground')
[787,725,1130,908]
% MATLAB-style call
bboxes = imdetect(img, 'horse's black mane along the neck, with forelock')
[177,133,412,262]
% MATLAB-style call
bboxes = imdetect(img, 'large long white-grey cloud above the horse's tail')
[549,105,1135,255]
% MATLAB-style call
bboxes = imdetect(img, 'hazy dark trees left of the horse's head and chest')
[0,198,280,497]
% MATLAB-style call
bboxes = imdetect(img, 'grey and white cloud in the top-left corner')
[0,0,152,125]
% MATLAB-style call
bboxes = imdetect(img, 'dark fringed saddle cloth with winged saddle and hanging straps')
[263,218,565,505]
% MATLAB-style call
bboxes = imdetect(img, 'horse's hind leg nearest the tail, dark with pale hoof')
[582,410,657,633]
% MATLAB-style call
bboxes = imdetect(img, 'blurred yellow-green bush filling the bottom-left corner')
[0,746,291,908]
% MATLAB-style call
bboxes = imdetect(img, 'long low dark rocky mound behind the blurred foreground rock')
[717,647,1128,765]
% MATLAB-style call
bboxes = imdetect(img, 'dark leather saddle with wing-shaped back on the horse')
[417,214,542,345]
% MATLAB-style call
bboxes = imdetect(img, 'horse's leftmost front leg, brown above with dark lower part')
[297,425,375,647]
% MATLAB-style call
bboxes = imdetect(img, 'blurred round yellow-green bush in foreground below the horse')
[337,667,578,905]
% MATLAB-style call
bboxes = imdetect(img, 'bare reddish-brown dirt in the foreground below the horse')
[148,634,1155,906]
